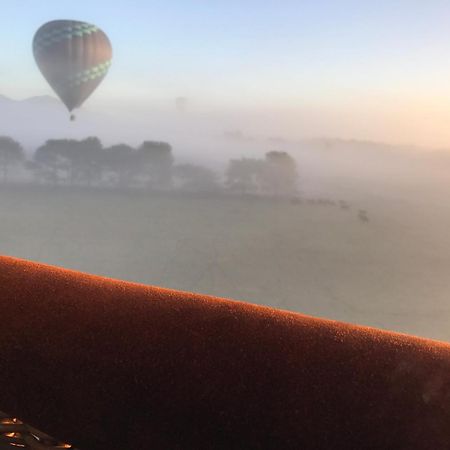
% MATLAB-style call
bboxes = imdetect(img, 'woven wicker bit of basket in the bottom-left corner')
[0,412,76,450]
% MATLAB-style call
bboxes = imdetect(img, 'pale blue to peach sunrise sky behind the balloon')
[0,0,450,148]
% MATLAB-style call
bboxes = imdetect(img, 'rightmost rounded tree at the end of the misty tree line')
[261,151,298,197]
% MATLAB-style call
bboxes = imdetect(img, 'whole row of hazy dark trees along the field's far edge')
[0,136,298,196]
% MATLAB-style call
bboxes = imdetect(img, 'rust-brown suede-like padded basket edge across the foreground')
[0,257,450,450]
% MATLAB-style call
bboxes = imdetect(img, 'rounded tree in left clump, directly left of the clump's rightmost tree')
[103,144,140,187]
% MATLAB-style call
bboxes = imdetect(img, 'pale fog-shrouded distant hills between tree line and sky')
[0,94,450,167]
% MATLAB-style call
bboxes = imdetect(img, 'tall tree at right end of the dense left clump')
[138,141,173,189]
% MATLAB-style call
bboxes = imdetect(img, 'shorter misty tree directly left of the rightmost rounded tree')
[226,158,264,194]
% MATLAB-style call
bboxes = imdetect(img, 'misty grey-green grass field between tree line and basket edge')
[0,187,450,340]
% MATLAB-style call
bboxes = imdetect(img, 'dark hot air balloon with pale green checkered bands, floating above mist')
[33,20,112,120]
